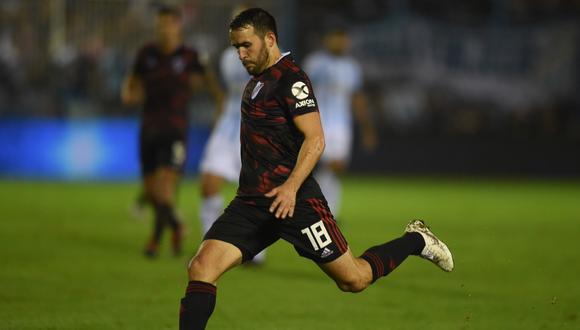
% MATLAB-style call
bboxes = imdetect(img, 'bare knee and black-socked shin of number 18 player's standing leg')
[179,239,242,330]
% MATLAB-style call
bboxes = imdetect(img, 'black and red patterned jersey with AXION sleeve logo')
[237,53,321,201]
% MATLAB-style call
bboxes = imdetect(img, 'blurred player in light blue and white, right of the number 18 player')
[304,25,377,218]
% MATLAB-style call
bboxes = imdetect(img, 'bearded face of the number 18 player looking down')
[230,26,269,76]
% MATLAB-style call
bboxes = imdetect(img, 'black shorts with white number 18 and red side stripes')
[204,197,348,263]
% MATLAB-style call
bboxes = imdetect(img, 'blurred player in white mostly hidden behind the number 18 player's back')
[199,5,265,263]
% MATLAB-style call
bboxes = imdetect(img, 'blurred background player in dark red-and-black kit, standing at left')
[121,7,223,257]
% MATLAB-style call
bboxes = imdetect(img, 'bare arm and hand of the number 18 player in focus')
[266,112,324,219]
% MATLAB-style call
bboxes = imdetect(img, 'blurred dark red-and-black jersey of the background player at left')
[133,44,204,135]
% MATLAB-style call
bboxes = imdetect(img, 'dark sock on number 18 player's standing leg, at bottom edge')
[179,281,217,330]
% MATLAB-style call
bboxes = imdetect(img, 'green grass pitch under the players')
[0,177,580,329]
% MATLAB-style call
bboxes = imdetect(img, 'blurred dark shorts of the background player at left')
[139,134,187,176]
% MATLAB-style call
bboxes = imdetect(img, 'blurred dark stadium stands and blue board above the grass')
[0,0,580,179]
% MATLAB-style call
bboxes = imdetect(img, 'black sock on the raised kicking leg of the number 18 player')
[360,233,425,282]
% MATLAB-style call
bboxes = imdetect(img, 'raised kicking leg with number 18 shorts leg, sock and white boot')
[288,198,453,292]
